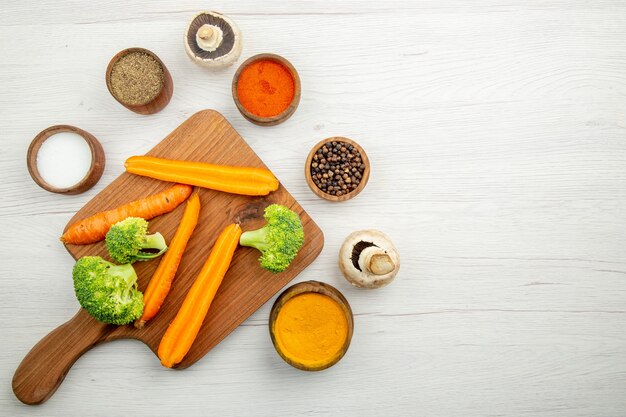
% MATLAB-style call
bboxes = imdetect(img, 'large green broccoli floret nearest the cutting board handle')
[72,256,143,324]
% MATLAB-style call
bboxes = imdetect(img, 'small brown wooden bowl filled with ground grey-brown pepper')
[106,48,174,114]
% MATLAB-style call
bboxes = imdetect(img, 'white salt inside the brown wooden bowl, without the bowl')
[37,132,91,188]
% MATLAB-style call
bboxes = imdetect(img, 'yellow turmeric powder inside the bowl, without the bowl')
[274,292,348,367]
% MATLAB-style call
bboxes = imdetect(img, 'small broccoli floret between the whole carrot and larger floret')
[105,217,167,264]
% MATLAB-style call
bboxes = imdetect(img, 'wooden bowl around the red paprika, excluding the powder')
[232,54,301,126]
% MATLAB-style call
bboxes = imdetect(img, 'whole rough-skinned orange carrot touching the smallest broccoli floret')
[61,184,193,245]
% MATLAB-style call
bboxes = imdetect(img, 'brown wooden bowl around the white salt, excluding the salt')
[26,125,106,194]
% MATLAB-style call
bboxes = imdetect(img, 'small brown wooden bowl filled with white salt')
[26,125,105,194]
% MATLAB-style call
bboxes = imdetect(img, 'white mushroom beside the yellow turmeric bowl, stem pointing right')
[339,230,400,288]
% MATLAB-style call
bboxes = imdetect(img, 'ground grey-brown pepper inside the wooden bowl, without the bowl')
[110,51,165,106]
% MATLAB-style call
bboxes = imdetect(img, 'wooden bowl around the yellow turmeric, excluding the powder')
[269,281,354,371]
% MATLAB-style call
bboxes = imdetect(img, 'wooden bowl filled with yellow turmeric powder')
[269,281,354,371]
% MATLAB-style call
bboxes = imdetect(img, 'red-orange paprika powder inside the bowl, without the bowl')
[237,59,295,117]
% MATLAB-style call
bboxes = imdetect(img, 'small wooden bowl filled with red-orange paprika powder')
[232,54,300,126]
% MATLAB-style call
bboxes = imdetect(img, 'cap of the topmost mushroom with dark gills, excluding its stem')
[185,11,242,68]
